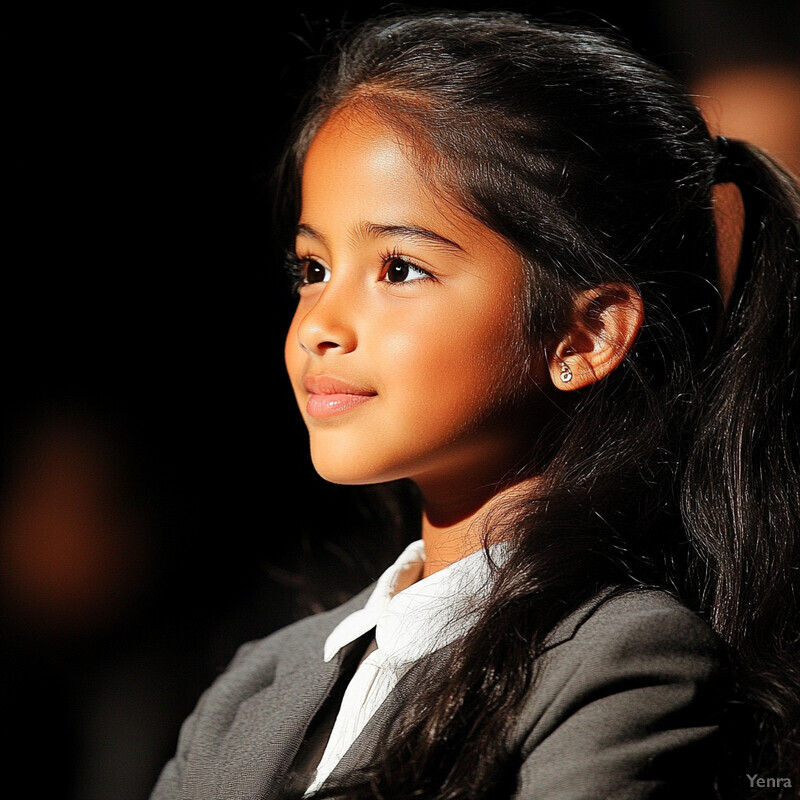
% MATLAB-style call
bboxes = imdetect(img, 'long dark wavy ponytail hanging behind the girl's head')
[682,139,800,786]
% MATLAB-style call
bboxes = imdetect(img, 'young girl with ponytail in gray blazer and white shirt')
[152,7,800,800]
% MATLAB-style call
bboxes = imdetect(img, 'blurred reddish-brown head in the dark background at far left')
[0,409,153,641]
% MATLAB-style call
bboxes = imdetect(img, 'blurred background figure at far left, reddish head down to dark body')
[0,406,171,800]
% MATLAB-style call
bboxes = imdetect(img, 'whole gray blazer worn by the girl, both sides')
[151,587,725,800]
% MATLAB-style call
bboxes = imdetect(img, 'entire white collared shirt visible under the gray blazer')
[306,540,491,795]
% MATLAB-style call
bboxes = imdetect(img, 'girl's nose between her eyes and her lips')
[296,284,357,355]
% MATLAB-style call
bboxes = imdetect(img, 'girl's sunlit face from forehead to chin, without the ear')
[285,106,549,492]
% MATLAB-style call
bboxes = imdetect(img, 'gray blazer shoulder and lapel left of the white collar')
[151,587,371,800]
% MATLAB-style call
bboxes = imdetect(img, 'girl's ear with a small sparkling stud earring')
[548,283,644,391]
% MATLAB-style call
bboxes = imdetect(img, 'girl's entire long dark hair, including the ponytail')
[278,7,800,800]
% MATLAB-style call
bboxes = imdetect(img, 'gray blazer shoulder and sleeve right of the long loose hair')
[517,589,727,798]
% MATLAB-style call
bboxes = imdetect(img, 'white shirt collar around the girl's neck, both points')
[323,539,497,663]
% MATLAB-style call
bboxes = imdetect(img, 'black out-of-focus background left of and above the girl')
[0,2,797,800]
